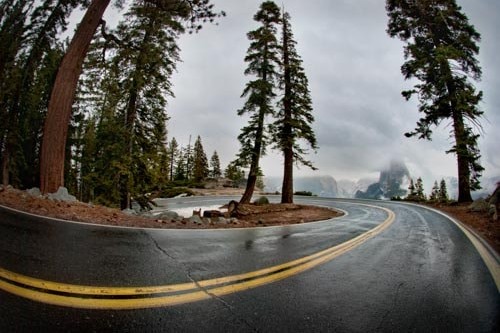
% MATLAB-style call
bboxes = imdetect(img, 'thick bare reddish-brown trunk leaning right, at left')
[40,0,110,193]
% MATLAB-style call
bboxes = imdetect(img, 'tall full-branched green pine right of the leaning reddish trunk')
[113,1,183,209]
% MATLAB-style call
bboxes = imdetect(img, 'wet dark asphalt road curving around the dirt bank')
[0,197,500,332]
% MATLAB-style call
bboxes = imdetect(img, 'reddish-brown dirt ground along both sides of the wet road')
[0,187,500,253]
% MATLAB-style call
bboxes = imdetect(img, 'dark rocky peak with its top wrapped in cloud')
[354,160,410,199]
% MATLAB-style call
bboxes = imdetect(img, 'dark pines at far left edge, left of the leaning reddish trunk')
[0,0,85,187]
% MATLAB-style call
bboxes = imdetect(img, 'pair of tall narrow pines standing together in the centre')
[236,1,317,203]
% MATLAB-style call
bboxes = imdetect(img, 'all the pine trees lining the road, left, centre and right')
[0,0,490,241]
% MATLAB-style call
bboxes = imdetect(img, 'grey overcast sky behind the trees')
[113,0,500,182]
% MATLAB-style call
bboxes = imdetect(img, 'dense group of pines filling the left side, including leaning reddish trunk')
[0,0,224,208]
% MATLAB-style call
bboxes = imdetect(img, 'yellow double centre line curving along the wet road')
[0,206,394,310]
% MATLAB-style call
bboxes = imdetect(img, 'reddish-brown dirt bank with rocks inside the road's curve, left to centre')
[0,188,341,229]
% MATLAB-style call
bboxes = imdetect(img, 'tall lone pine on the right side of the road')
[386,0,484,202]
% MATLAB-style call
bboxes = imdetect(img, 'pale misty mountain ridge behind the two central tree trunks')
[264,176,338,198]
